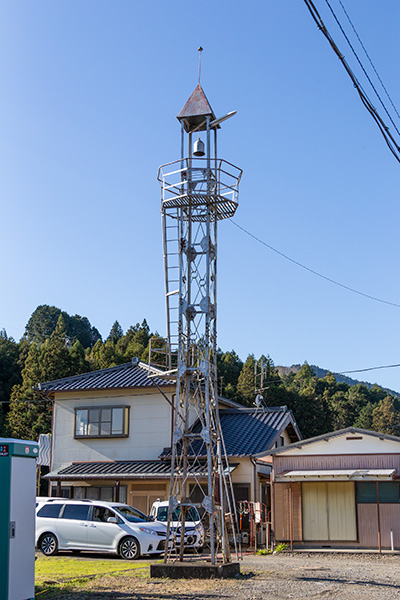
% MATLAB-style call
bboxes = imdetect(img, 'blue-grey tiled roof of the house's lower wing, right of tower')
[161,406,300,458]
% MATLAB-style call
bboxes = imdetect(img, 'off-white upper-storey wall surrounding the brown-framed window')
[51,390,172,470]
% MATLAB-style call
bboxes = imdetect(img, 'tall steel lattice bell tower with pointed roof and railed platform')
[154,72,242,564]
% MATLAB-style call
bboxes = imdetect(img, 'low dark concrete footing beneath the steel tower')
[150,562,240,579]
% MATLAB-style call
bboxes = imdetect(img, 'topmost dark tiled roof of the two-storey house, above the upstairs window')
[34,360,172,392]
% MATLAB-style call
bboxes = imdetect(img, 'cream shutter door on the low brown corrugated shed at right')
[302,482,357,541]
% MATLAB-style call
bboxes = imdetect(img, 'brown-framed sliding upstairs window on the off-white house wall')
[75,406,129,438]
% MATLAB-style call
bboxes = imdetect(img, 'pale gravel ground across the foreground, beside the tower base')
[44,553,400,600]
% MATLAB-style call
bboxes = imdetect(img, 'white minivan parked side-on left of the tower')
[36,498,167,560]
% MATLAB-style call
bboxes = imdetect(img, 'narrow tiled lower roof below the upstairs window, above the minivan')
[45,460,207,481]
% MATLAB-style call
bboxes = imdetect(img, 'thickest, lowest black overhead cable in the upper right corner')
[304,0,400,163]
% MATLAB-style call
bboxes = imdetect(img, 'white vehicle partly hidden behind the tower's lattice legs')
[150,499,204,553]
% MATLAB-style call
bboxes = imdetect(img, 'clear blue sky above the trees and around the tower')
[0,0,400,391]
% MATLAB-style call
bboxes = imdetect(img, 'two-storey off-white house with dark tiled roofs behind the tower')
[36,359,301,512]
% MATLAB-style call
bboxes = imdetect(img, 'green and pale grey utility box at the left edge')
[0,438,39,600]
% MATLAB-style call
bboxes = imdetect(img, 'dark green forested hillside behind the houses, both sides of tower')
[0,305,400,439]
